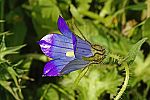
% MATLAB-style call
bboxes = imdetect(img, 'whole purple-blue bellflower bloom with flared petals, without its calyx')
[38,16,102,76]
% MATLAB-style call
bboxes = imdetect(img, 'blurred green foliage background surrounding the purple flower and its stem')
[0,0,150,100]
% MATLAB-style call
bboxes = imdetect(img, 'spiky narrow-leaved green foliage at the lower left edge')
[0,35,25,100]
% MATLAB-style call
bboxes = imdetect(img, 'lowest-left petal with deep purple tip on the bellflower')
[43,59,70,76]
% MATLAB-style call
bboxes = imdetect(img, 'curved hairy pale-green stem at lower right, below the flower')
[114,63,129,100]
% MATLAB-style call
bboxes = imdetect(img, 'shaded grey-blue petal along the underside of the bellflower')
[60,59,89,75]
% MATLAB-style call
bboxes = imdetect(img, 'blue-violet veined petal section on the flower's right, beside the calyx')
[75,37,93,59]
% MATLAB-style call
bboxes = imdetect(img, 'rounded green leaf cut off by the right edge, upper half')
[142,18,150,41]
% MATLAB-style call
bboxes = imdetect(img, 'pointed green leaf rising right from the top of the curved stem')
[124,38,147,64]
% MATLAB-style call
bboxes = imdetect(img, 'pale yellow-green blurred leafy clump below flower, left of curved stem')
[83,69,122,100]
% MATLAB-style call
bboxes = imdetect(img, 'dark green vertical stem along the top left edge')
[0,0,4,33]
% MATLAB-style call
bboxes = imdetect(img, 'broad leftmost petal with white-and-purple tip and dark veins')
[39,34,74,59]
